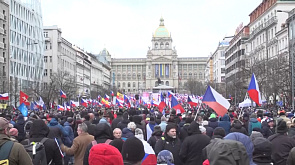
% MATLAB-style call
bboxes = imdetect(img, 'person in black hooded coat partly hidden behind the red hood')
[83,123,114,165]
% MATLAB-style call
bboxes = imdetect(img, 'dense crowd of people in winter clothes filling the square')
[0,108,295,165]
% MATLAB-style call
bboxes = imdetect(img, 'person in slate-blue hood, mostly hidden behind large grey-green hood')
[224,132,255,165]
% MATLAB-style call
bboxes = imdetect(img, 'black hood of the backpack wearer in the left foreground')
[30,119,49,138]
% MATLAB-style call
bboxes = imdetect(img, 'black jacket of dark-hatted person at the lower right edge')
[268,133,295,165]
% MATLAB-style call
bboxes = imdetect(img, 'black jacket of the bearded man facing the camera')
[155,133,182,165]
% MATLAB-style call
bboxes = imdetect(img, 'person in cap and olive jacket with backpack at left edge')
[0,117,33,165]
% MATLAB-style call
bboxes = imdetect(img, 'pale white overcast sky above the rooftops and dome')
[41,0,262,58]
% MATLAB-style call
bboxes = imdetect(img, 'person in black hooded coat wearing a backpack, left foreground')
[22,119,63,165]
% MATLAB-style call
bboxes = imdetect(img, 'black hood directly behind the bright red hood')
[94,123,113,140]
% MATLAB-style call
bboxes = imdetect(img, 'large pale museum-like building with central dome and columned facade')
[111,18,207,94]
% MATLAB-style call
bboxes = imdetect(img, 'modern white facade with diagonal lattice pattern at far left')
[9,0,44,102]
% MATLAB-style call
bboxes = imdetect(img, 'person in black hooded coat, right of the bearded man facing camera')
[179,121,210,165]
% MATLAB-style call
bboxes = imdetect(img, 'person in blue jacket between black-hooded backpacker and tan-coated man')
[47,118,69,139]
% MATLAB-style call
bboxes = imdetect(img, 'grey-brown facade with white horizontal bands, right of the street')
[225,26,250,104]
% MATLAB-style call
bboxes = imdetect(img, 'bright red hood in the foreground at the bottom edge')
[88,143,123,165]
